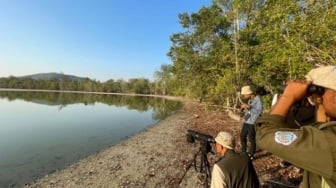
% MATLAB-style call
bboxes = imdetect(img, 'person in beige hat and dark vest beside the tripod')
[211,131,260,188]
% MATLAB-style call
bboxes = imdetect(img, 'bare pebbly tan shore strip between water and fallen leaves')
[24,101,200,188]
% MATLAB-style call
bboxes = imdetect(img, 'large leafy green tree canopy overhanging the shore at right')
[167,0,336,105]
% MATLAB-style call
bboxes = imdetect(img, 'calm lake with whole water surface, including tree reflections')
[0,91,181,187]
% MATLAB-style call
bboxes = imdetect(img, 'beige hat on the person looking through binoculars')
[306,66,336,91]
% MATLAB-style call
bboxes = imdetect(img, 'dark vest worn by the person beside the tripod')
[216,150,259,188]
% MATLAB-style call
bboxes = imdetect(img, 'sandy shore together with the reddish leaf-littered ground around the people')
[25,101,301,188]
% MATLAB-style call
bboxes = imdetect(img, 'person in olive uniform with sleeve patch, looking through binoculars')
[255,66,336,188]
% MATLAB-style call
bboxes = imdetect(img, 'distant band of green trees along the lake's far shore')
[0,76,151,94]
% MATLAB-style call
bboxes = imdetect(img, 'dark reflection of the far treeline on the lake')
[0,91,181,119]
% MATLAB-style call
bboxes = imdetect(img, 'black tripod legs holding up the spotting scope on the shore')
[179,141,211,188]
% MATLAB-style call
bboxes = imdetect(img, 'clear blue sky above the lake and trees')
[0,0,212,82]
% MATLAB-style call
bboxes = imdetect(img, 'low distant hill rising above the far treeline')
[21,73,89,81]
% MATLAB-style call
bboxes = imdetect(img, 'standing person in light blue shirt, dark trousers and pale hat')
[240,86,263,159]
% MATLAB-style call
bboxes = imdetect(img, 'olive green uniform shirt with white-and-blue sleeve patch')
[256,115,336,188]
